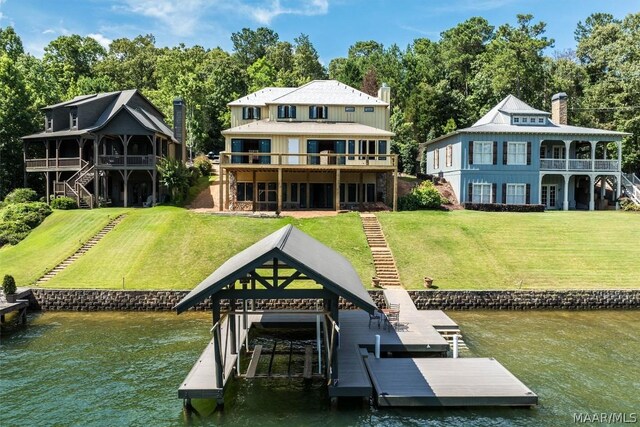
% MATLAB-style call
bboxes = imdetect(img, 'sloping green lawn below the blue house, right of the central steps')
[378,211,640,289]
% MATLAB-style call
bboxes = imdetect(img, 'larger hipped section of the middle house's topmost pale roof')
[271,80,389,106]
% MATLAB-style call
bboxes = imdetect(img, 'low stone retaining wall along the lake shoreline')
[30,289,640,311]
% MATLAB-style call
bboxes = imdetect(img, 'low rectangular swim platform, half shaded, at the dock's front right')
[365,354,538,406]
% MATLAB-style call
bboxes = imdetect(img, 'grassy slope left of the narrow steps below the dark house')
[0,209,129,286]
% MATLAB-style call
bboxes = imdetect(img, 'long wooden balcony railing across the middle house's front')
[220,152,398,168]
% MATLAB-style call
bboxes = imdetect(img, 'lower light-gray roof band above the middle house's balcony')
[222,119,394,137]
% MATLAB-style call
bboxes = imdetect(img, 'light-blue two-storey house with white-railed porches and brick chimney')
[425,93,628,210]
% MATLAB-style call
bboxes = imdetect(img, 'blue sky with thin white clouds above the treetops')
[0,0,640,64]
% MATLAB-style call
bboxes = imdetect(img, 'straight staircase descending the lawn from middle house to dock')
[360,213,402,287]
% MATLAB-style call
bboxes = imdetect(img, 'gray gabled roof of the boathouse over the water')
[174,225,376,313]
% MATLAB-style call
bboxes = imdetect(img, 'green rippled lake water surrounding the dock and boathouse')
[0,311,640,427]
